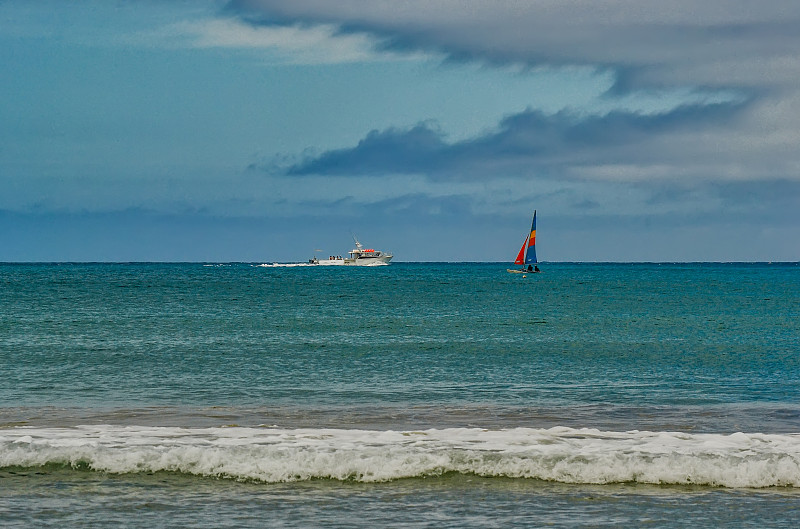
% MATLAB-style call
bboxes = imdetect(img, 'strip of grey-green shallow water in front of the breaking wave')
[0,468,800,529]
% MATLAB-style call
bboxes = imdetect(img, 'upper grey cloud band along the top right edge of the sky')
[228,0,800,88]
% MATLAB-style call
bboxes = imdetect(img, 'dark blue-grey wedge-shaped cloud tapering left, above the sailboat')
[286,104,739,179]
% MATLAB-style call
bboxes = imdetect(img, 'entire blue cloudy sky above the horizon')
[0,0,800,262]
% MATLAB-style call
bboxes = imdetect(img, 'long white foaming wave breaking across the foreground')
[0,425,800,488]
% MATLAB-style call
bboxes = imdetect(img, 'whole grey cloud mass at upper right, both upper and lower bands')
[228,0,800,185]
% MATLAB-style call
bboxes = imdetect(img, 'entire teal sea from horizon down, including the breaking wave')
[0,263,800,529]
